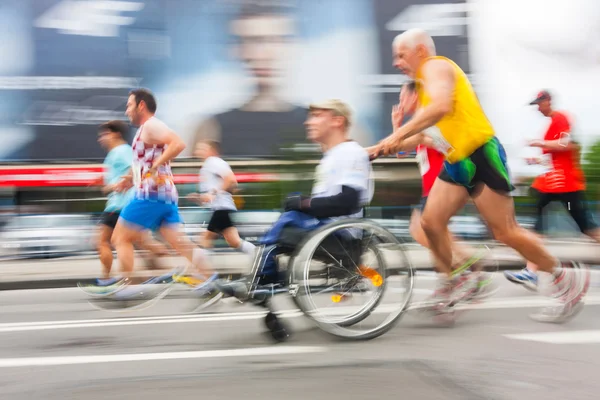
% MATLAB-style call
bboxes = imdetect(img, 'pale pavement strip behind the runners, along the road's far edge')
[0,240,600,290]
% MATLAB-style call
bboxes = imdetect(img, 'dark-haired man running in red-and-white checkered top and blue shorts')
[113,89,217,292]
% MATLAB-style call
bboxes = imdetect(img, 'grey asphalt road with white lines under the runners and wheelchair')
[0,273,600,400]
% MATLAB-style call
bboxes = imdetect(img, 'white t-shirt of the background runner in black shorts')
[200,157,237,211]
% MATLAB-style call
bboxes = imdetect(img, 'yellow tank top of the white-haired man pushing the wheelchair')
[415,56,494,163]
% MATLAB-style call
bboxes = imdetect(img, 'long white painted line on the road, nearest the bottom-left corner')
[0,346,327,368]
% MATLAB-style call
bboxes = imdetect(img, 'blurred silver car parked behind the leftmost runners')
[0,214,95,258]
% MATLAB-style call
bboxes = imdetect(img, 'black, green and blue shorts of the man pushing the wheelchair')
[439,136,515,195]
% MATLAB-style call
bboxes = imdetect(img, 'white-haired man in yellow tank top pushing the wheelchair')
[368,29,590,322]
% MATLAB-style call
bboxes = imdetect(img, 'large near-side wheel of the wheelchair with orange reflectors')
[288,219,414,340]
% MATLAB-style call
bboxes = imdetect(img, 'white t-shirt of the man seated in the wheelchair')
[312,141,374,219]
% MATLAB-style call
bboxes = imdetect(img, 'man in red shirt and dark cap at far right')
[504,90,600,290]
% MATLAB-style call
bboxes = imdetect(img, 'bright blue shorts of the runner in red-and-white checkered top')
[120,199,183,230]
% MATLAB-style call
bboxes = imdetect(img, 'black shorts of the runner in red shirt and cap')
[532,189,598,233]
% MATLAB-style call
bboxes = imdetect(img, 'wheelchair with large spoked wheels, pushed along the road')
[221,218,414,342]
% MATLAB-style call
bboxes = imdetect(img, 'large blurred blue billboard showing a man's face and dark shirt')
[0,0,471,162]
